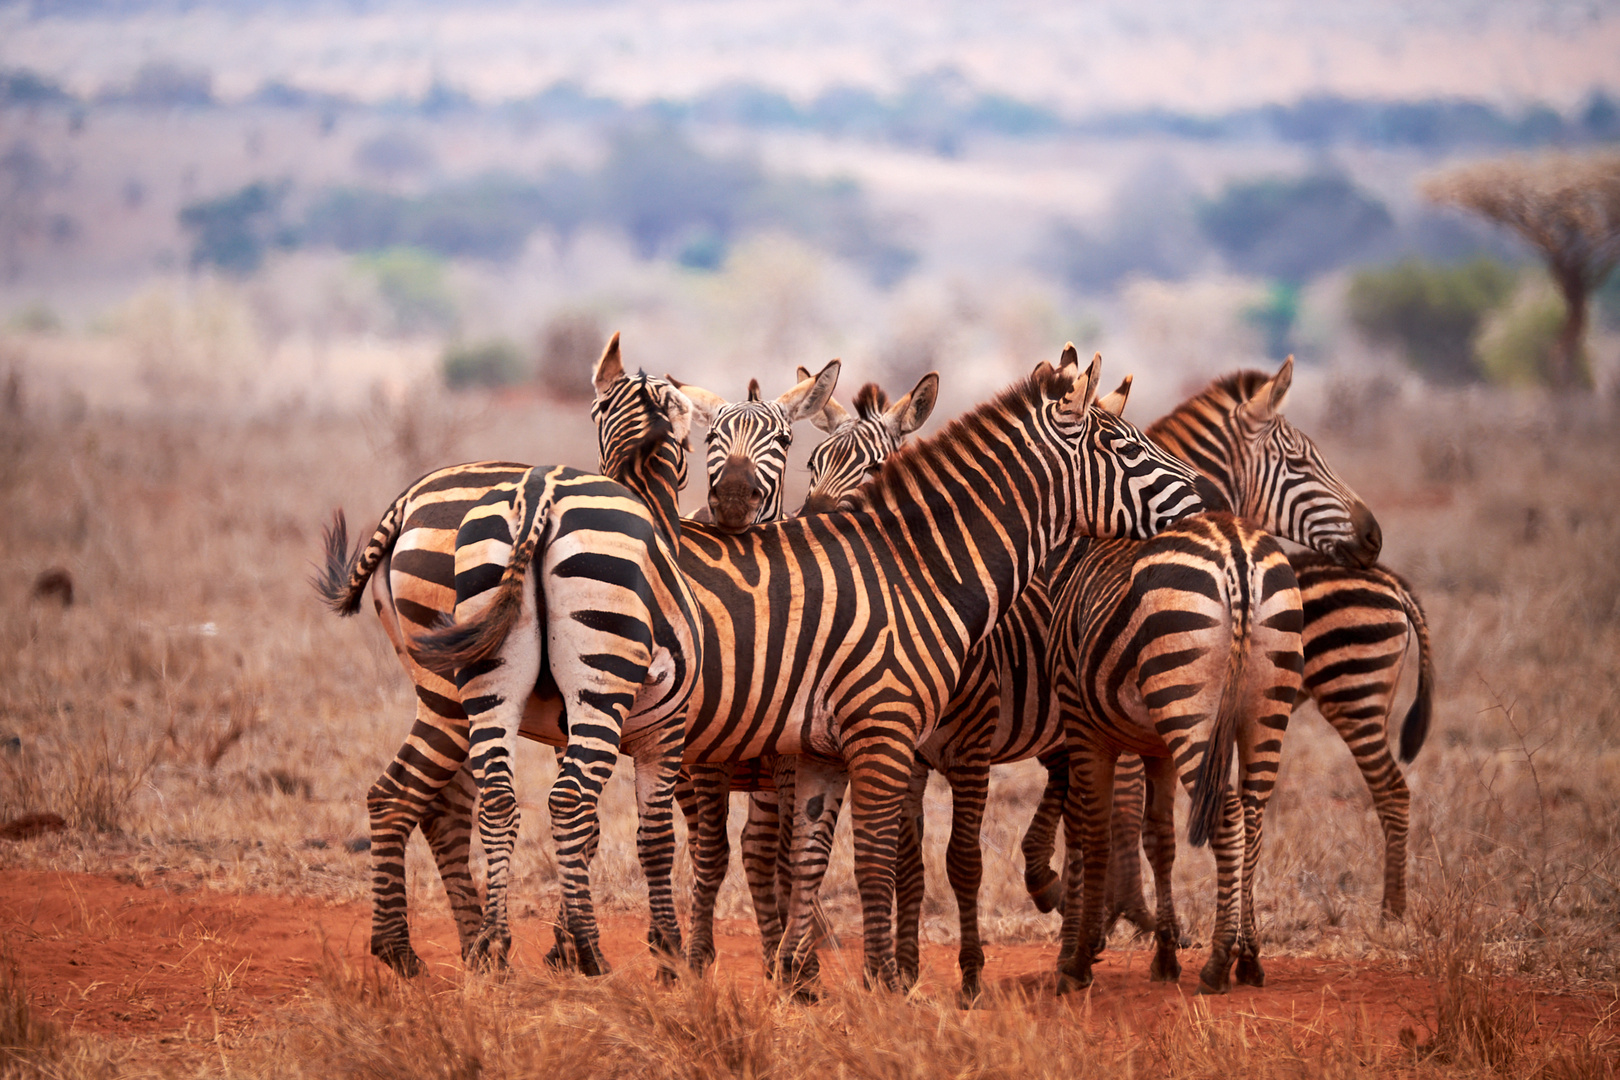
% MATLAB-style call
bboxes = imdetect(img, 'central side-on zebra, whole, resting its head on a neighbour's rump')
[651,345,1202,986]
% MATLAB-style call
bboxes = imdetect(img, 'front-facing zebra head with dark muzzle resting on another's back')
[671,359,841,533]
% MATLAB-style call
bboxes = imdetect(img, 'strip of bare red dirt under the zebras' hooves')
[0,870,1605,1041]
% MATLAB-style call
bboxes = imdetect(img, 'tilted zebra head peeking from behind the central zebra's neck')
[799,368,940,517]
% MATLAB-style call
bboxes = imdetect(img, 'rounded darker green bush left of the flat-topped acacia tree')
[1349,257,1518,382]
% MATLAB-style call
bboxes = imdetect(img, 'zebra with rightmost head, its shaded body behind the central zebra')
[897,361,1382,999]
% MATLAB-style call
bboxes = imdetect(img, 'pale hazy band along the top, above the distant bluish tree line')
[0,0,1620,112]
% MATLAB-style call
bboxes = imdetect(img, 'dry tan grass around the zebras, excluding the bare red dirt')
[0,361,1620,1077]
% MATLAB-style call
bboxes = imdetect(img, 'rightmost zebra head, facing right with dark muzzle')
[1149,356,1383,567]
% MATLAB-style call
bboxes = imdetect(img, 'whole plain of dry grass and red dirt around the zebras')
[0,359,1620,1078]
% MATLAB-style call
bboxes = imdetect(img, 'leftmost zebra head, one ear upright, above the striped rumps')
[591,334,693,534]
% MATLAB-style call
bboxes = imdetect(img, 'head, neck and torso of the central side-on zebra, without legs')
[680,345,1202,761]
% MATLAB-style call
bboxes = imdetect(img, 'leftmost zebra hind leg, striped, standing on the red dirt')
[366,705,469,976]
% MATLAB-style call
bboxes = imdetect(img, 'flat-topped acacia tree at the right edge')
[1424,154,1620,389]
